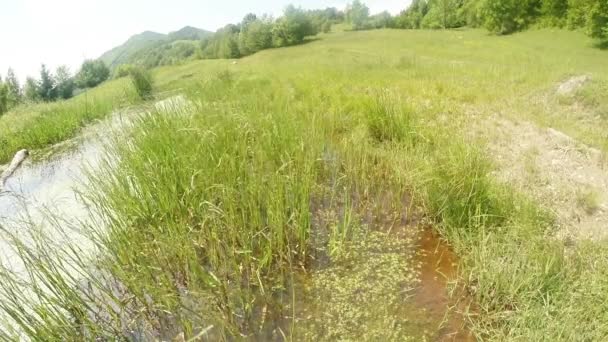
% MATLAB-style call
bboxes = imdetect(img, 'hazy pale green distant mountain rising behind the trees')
[99,26,213,69]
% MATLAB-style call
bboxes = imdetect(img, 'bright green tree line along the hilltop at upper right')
[346,0,608,39]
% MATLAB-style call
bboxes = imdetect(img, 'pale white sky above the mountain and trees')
[0,0,410,82]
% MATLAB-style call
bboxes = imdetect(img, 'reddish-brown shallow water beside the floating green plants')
[414,228,476,341]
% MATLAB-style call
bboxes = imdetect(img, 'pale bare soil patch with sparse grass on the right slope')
[480,116,608,240]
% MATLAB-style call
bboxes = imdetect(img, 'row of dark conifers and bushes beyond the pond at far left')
[0,60,110,115]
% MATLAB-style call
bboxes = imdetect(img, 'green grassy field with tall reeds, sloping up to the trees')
[0,30,608,341]
